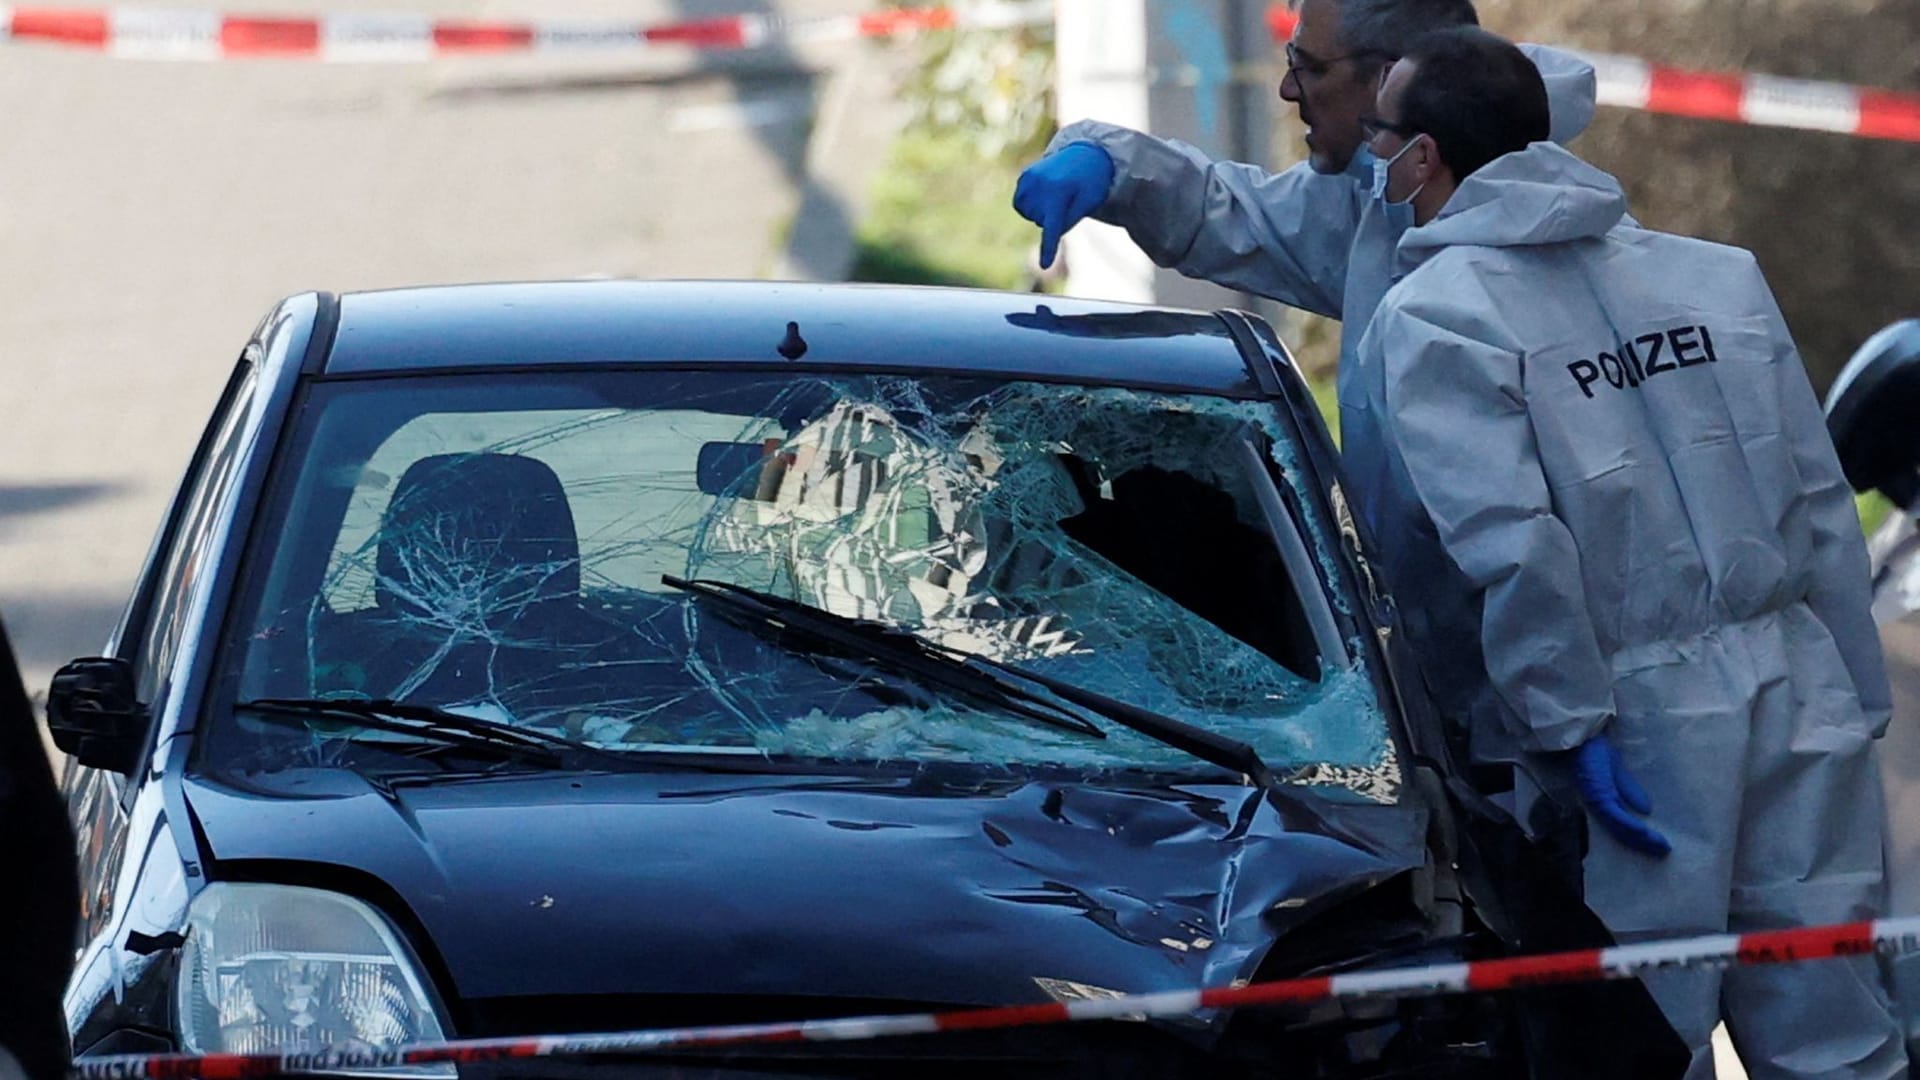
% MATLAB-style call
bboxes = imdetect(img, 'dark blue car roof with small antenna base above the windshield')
[323,281,1263,398]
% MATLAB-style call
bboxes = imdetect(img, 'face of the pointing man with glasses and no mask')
[1281,0,1382,173]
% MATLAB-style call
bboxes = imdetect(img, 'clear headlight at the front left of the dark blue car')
[179,882,445,1074]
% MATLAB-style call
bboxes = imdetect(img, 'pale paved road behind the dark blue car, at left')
[0,0,887,686]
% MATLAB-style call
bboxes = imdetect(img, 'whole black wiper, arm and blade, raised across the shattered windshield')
[660,575,1275,788]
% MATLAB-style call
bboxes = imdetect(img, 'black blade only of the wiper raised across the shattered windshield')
[660,575,1106,738]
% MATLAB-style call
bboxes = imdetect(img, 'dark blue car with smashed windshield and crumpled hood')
[50,282,1684,1078]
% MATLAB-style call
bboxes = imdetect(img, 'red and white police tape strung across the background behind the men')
[0,0,1920,142]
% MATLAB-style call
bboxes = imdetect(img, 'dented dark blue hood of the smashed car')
[188,769,1425,1005]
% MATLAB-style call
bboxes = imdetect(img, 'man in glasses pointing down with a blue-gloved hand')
[1014,0,1594,611]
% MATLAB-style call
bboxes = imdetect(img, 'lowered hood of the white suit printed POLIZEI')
[1398,142,1626,273]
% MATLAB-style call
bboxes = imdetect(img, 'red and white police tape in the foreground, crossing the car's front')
[71,917,1920,1080]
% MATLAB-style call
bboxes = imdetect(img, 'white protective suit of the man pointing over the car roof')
[1048,44,1596,541]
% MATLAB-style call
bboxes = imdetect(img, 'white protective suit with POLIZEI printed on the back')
[1356,142,1907,1080]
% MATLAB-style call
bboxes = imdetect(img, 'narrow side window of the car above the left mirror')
[127,357,259,705]
